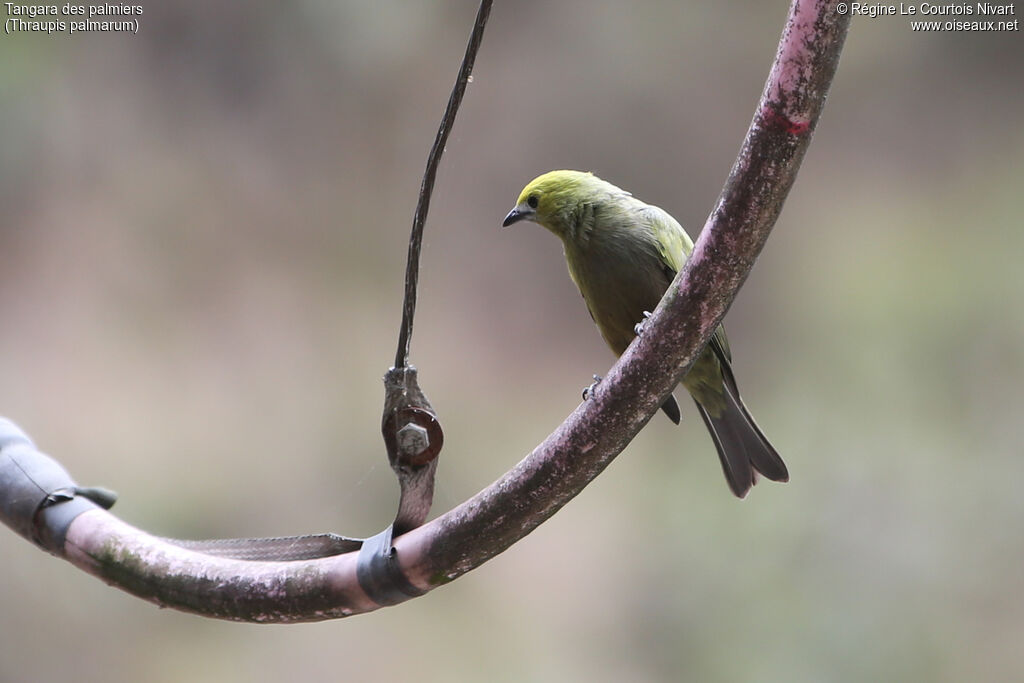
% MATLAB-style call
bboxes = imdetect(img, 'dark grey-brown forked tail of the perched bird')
[697,382,790,498]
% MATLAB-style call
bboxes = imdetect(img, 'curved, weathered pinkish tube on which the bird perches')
[0,0,849,622]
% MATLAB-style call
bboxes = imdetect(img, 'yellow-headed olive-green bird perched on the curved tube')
[502,170,790,499]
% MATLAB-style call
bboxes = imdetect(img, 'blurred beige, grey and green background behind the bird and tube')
[0,0,1024,683]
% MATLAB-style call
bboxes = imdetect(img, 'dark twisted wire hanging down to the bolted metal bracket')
[394,0,492,368]
